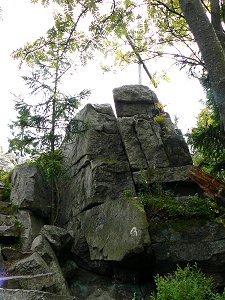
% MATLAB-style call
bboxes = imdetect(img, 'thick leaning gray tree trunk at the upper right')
[179,0,225,137]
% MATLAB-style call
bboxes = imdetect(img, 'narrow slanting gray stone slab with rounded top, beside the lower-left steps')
[31,235,70,295]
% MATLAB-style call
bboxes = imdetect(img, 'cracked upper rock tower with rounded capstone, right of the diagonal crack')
[113,85,192,171]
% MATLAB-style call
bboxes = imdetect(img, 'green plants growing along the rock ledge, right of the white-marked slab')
[139,169,222,220]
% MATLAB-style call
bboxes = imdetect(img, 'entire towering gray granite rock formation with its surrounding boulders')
[3,85,225,300]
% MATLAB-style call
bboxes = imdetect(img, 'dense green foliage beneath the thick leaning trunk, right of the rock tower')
[187,76,225,179]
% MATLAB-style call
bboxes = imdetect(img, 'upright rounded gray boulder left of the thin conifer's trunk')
[10,165,51,218]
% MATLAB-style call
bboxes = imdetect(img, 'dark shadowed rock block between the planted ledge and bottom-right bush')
[150,220,225,286]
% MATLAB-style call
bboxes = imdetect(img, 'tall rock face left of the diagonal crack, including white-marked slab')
[59,105,150,261]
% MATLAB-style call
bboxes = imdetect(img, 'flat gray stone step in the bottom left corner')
[0,288,76,300]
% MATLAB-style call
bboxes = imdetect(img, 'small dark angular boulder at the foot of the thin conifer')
[40,225,73,254]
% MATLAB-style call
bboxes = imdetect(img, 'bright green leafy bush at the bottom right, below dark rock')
[150,265,225,300]
